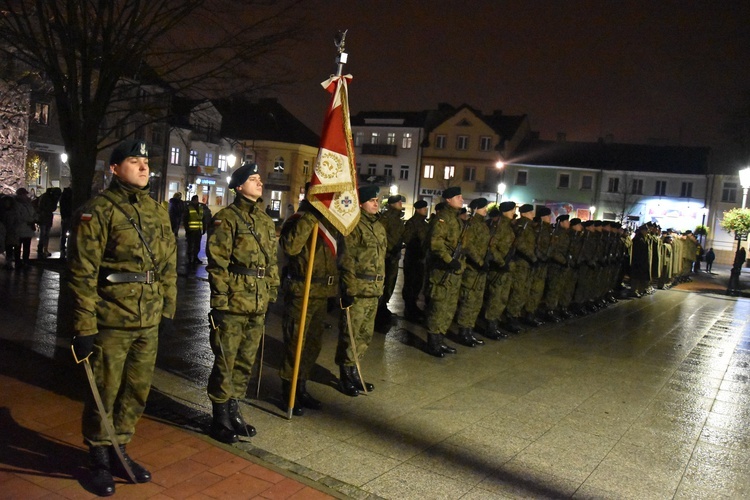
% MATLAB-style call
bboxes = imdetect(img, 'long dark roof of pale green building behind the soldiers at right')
[508,140,710,175]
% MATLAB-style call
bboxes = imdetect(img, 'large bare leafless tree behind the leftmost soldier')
[0,0,301,206]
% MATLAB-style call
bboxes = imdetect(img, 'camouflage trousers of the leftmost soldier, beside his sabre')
[82,326,159,446]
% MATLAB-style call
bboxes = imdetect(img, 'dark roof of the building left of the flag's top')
[214,98,320,148]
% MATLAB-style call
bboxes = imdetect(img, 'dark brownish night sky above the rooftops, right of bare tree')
[280,0,750,154]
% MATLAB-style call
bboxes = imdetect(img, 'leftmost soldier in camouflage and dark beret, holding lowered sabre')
[68,140,177,496]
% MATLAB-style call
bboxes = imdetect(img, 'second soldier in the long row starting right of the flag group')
[456,198,490,347]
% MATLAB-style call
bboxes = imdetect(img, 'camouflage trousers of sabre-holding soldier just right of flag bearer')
[336,297,379,366]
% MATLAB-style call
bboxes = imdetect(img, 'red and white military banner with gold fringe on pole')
[308,75,359,238]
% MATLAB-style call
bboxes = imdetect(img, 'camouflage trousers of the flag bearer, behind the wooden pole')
[279,292,328,380]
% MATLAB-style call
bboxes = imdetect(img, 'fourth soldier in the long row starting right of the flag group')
[504,203,538,333]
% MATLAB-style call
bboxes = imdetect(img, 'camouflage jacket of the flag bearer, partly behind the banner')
[279,205,339,297]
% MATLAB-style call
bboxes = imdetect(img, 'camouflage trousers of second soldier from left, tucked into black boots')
[208,314,266,403]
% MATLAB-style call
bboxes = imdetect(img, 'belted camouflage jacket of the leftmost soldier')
[68,177,177,335]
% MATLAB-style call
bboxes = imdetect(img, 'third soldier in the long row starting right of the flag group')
[484,201,516,340]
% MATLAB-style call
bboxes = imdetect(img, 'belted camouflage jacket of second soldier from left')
[206,194,279,314]
